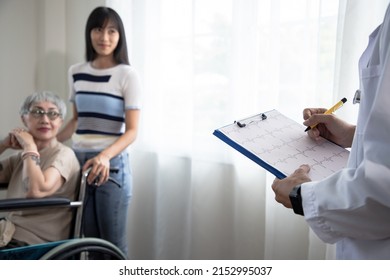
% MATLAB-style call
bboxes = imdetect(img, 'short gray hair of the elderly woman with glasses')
[19,91,66,119]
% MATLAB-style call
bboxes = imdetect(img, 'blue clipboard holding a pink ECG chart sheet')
[213,109,349,181]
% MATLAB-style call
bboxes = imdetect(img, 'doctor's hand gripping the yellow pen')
[303,108,356,148]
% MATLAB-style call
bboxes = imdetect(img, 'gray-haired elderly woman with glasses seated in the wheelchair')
[0,92,80,248]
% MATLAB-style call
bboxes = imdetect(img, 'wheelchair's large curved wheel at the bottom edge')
[41,238,126,260]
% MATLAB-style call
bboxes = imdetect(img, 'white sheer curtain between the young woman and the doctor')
[108,0,387,259]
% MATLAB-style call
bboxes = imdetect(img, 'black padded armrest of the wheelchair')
[0,197,71,212]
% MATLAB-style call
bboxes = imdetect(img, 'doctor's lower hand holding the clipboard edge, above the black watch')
[272,164,311,208]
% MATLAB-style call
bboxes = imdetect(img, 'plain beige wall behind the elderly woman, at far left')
[0,0,38,138]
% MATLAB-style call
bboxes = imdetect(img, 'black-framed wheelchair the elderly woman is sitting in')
[0,170,126,260]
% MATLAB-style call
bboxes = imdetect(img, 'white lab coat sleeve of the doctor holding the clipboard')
[301,10,390,243]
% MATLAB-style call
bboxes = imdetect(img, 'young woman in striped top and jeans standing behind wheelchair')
[58,7,140,254]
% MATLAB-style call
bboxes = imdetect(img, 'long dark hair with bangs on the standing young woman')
[85,7,130,65]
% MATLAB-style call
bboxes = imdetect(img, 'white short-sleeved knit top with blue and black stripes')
[69,62,141,151]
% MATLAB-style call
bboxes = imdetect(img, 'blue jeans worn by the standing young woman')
[76,151,132,256]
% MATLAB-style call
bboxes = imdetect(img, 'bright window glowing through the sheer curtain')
[131,0,338,162]
